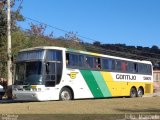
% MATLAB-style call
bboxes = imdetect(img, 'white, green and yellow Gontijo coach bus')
[12,46,153,101]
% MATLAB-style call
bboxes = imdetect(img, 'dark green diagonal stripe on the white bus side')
[81,70,104,98]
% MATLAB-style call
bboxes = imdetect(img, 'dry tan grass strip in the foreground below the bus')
[0,97,160,115]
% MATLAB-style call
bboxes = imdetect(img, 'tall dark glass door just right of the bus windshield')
[45,50,62,87]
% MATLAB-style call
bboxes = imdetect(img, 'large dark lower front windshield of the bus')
[14,61,42,85]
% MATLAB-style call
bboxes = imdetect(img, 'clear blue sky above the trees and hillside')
[16,0,160,47]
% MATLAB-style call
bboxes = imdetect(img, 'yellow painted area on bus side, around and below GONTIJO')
[101,72,153,96]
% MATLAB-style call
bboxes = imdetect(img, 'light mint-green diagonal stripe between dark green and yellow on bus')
[92,71,111,97]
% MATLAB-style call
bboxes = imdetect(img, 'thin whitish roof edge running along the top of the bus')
[20,46,152,64]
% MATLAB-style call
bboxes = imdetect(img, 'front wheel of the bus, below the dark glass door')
[59,87,73,101]
